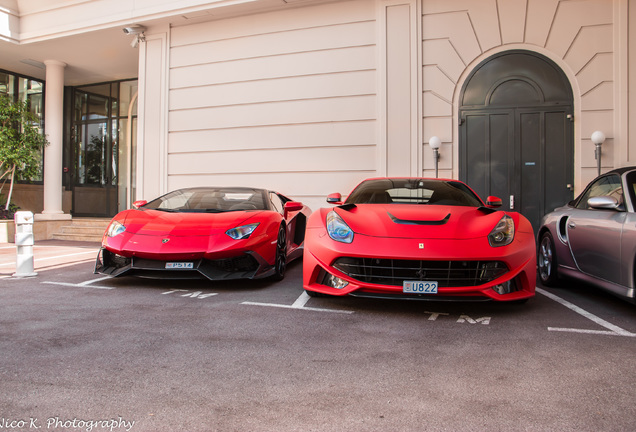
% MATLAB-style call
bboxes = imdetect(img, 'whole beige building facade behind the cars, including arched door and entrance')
[0,0,636,233]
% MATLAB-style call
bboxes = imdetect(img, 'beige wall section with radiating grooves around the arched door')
[422,0,628,192]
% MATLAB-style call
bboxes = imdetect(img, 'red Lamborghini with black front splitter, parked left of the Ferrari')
[95,188,310,280]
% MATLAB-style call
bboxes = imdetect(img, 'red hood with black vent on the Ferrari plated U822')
[334,204,504,239]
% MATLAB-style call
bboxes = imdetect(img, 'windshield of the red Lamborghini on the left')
[142,188,267,213]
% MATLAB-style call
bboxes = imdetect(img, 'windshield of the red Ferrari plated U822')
[346,178,483,207]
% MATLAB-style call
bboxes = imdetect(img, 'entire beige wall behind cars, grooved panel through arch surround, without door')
[133,0,636,208]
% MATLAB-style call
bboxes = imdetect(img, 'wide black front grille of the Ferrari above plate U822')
[333,257,508,287]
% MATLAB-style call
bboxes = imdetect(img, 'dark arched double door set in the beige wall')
[459,51,574,231]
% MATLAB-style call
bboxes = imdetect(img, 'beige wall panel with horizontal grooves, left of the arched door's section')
[167,1,377,208]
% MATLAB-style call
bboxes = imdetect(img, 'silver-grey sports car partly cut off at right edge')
[537,167,636,303]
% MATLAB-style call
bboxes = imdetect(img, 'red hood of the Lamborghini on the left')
[116,210,262,236]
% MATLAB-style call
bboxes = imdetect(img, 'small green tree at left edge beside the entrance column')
[0,95,48,210]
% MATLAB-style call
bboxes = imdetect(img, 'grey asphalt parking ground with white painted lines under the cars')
[0,241,636,432]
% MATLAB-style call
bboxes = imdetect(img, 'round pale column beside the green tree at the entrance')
[37,60,71,220]
